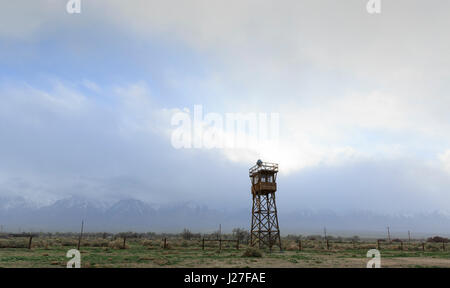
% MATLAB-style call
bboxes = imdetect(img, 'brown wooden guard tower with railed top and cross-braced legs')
[249,160,281,251]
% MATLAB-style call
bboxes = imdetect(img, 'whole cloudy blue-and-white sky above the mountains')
[0,0,450,213]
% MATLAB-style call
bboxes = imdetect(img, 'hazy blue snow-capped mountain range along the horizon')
[0,196,450,237]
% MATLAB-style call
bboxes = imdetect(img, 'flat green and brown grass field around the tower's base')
[0,238,450,268]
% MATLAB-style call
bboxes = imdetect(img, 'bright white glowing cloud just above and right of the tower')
[214,86,450,172]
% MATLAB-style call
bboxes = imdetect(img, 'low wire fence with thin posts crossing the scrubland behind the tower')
[0,233,447,252]
